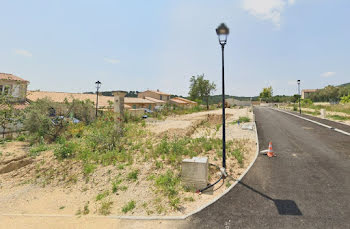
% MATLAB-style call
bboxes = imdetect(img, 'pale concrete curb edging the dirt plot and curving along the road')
[1,122,259,220]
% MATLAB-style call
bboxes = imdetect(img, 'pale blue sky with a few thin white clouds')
[0,0,350,96]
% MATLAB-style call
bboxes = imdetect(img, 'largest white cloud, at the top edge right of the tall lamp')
[243,0,295,27]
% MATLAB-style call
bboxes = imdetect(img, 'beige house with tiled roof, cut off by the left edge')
[0,73,29,103]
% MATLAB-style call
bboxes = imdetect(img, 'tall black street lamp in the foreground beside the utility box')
[216,23,230,172]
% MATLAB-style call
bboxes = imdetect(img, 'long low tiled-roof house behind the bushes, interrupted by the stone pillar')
[27,91,156,110]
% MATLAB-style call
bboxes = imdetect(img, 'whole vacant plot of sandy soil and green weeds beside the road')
[0,108,256,216]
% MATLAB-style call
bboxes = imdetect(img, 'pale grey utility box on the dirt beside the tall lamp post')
[181,157,208,189]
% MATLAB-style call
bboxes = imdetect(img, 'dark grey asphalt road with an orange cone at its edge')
[187,107,350,229]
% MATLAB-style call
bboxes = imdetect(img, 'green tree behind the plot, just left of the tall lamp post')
[189,74,216,110]
